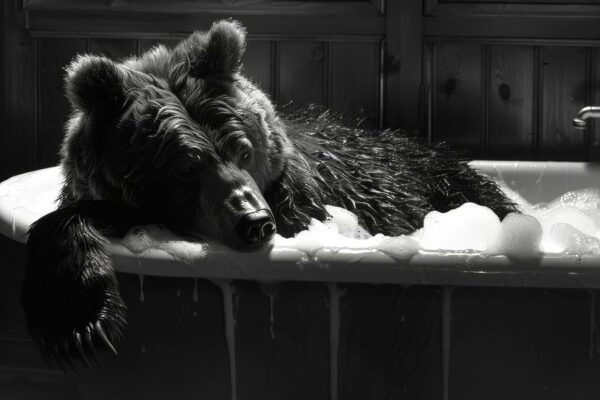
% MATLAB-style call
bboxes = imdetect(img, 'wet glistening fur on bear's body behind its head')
[265,107,515,236]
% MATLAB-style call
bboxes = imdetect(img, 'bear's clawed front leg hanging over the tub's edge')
[22,201,135,370]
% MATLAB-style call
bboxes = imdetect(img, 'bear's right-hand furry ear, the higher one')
[187,20,246,78]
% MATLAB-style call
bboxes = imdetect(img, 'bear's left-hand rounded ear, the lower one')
[65,55,126,114]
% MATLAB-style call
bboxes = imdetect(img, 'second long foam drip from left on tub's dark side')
[327,283,346,400]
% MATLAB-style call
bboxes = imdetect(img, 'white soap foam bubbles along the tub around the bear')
[123,188,600,263]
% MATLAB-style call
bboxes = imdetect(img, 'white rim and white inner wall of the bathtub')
[0,161,600,288]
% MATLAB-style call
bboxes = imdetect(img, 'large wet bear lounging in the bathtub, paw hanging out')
[22,20,516,367]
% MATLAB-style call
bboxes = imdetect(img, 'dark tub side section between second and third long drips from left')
[338,285,442,400]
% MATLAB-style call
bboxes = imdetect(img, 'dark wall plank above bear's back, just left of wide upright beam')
[328,42,380,125]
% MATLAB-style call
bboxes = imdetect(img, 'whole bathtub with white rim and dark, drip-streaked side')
[0,161,600,399]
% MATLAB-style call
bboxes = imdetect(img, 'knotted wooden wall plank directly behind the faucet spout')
[541,46,590,161]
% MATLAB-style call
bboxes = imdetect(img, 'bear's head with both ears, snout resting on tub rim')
[62,21,292,249]
